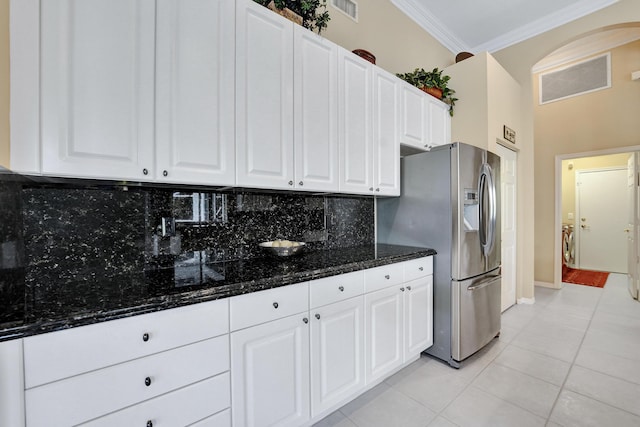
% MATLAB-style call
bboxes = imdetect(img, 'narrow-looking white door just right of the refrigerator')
[497,145,518,311]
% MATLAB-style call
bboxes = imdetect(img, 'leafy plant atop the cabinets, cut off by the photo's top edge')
[254,0,331,34]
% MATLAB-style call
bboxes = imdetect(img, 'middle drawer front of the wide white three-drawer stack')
[25,335,229,427]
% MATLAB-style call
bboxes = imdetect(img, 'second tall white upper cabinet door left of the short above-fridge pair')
[338,48,373,194]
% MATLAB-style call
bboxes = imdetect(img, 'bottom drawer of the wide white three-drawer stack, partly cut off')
[82,372,231,427]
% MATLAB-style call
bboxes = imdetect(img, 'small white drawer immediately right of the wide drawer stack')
[230,282,309,331]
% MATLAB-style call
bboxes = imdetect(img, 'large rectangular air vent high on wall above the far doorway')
[540,53,611,104]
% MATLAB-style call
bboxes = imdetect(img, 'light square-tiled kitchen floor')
[315,274,640,427]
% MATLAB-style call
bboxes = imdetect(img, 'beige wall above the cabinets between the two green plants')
[323,0,455,74]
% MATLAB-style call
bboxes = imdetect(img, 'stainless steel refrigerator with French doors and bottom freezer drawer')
[376,143,501,367]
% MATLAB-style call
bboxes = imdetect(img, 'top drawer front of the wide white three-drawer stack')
[24,299,229,389]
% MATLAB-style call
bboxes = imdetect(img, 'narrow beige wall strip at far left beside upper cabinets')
[0,0,9,171]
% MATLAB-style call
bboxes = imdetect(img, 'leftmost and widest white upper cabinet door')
[40,0,155,179]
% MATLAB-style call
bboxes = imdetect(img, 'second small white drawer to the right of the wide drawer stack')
[309,270,364,308]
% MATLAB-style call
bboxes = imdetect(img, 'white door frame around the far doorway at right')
[552,145,640,289]
